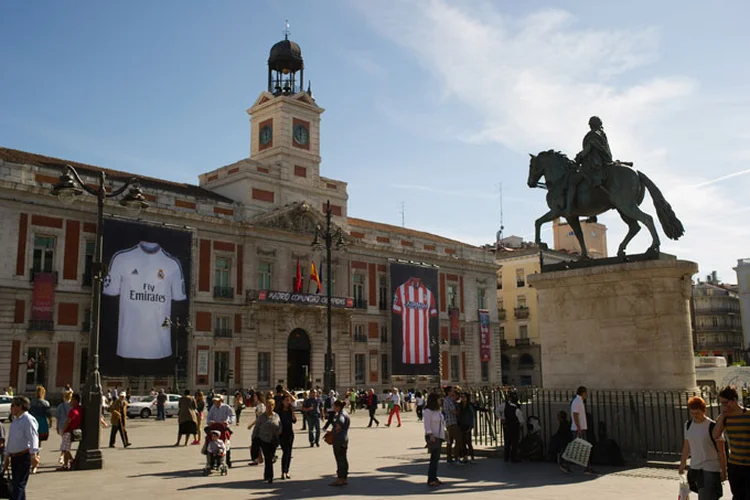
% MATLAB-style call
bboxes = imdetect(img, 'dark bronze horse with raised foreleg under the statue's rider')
[528,150,685,258]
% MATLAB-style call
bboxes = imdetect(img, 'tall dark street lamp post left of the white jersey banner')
[52,165,148,470]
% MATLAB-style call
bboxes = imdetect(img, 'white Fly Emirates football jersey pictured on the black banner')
[103,241,187,359]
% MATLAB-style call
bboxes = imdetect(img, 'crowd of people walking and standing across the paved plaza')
[0,385,750,500]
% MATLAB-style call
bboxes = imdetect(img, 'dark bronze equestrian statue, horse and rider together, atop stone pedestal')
[528,116,685,258]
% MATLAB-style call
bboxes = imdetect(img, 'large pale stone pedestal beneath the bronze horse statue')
[529,259,698,390]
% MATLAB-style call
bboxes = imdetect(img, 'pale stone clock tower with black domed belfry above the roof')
[200,32,348,219]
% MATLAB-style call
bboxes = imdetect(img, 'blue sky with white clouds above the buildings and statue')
[0,0,750,282]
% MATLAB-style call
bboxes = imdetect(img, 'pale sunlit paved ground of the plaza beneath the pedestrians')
[28,410,678,500]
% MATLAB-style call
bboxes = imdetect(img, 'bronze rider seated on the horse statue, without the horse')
[563,116,613,214]
